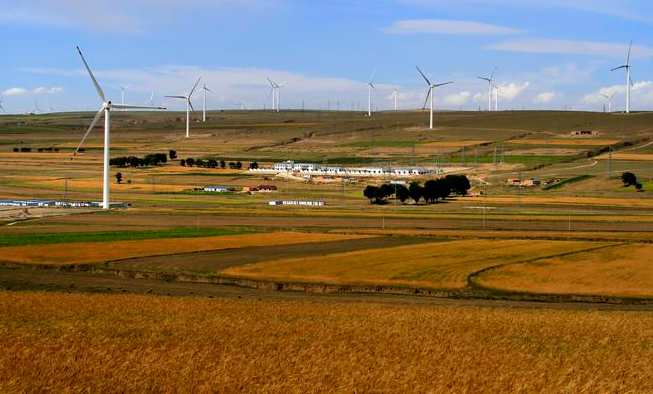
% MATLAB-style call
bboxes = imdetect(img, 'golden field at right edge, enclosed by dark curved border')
[479,244,653,297]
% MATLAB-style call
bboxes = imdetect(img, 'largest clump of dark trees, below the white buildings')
[363,175,470,204]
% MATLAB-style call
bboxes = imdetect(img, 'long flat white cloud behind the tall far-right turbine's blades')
[485,39,653,60]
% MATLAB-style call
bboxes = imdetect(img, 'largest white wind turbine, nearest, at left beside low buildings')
[70,47,165,209]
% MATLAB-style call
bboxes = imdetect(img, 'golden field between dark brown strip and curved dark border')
[222,240,593,288]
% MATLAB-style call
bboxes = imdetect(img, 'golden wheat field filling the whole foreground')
[0,292,653,393]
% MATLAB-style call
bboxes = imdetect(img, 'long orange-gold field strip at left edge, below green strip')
[0,232,365,264]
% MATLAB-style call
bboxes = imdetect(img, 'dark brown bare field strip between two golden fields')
[111,236,433,272]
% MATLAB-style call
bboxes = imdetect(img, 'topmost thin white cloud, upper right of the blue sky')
[385,19,521,35]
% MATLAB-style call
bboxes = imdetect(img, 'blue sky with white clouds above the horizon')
[0,0,653,113]
